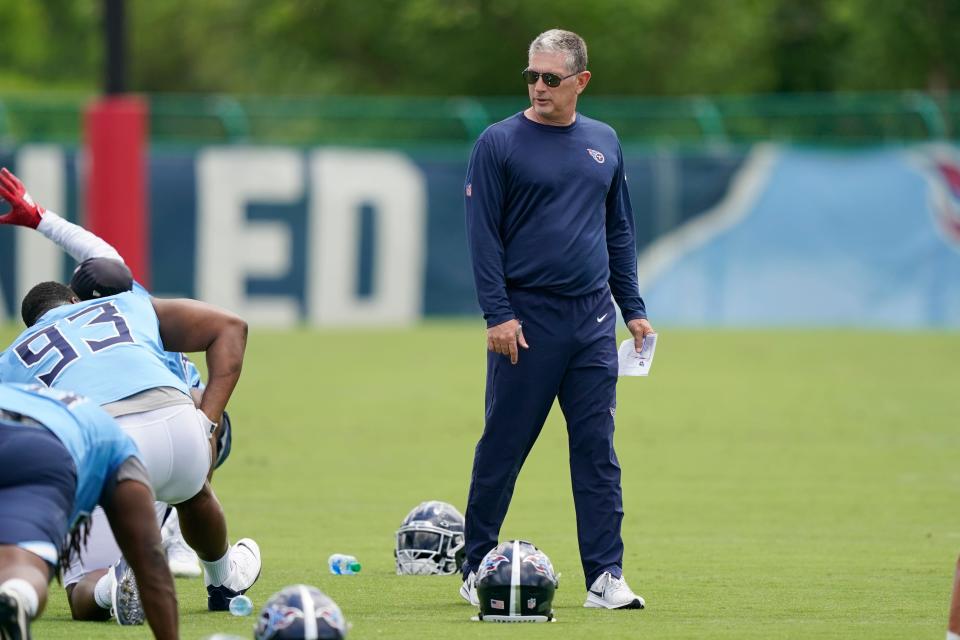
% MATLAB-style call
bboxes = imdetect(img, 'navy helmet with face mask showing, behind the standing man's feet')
[393,500,466,576]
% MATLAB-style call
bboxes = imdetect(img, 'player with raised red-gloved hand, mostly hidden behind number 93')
[0,169,232,577]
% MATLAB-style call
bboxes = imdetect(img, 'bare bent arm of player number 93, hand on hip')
[153,298,247,423]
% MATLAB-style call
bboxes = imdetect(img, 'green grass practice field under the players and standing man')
[7,322,960,640]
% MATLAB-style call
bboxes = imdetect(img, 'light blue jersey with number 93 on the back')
[0,292,189,405]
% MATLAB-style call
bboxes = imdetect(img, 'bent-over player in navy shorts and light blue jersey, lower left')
[0,384,178,640]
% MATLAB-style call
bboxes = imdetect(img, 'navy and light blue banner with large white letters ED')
[0,145,960,328]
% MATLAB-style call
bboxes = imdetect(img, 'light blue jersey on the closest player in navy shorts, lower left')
[0,384,140,528]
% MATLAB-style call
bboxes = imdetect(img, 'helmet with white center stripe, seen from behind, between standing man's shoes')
[477,540,559,622]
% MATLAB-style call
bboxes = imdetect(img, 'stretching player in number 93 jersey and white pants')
[0,282,260,623]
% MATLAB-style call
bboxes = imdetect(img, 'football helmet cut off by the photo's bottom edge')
[253,584,349,640]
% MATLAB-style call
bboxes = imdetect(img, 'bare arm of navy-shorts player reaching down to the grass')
[101,458,179,640]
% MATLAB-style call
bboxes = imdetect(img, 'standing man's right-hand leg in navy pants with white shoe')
[559,294,643,608]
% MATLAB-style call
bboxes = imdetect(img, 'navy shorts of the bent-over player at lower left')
[0,422,77,566]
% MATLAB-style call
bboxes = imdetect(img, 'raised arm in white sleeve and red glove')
[0,168,123,262]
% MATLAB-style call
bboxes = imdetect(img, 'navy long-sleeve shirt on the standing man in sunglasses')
[465,113,646,327]
